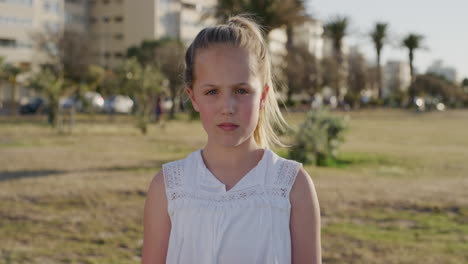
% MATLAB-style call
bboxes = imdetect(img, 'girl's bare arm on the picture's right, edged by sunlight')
[290,168,322,264]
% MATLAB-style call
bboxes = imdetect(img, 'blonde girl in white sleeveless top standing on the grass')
[142,16,321,264]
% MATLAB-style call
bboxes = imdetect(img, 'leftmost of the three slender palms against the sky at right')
[324,16,349,98]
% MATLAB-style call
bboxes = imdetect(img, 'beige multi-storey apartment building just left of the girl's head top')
[89,0,217,67]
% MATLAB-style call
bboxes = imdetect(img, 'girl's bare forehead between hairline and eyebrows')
[194,44,257,88]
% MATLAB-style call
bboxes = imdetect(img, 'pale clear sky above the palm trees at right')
[307,0,468,80]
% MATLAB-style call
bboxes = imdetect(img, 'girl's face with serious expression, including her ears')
[187,44,268,150]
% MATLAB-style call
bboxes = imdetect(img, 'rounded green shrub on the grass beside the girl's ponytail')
[289,110,347,166]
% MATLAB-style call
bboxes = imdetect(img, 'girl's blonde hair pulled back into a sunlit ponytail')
[185,15,289,148]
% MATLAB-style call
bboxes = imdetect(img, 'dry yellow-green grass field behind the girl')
[0,110,468,264]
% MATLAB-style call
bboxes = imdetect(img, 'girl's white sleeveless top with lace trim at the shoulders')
[163,149,302,264]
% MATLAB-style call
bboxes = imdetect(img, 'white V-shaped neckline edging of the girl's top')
[196,148,270,193]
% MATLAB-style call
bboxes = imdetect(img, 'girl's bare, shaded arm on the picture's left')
[141,171,171,264]
